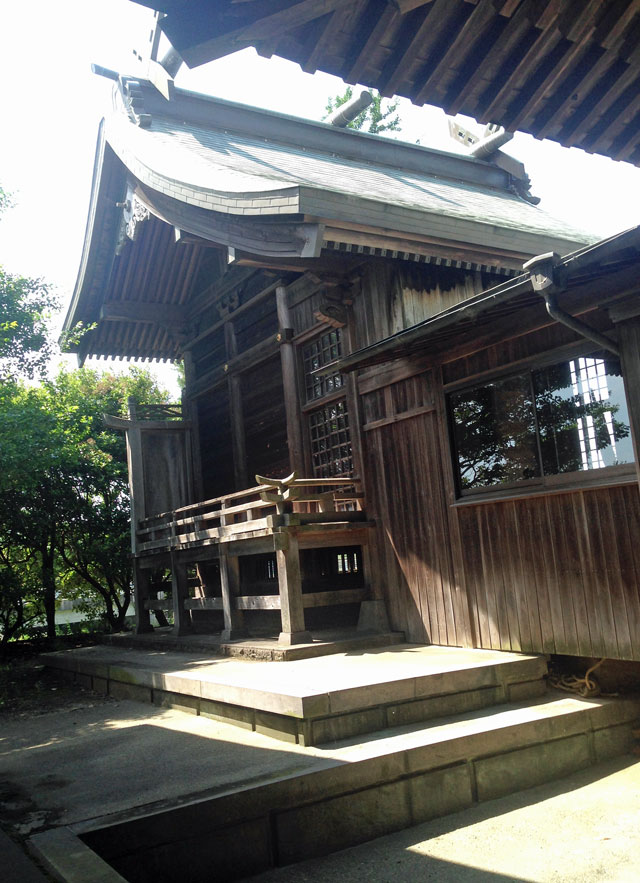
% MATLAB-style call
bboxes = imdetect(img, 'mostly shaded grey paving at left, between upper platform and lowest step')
[0,700,325,836]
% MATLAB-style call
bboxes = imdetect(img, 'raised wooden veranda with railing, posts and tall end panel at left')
[106,402,373,644]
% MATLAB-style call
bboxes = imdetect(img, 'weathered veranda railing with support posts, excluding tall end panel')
[136,475,370,643]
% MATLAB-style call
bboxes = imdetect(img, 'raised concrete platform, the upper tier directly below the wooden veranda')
[41,644,546,745]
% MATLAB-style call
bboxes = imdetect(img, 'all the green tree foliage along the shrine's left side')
[0,188,175,645]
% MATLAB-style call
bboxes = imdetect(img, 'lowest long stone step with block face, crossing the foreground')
[47,693,640,883]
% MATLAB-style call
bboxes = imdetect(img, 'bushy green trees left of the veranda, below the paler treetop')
[0,369,166,638]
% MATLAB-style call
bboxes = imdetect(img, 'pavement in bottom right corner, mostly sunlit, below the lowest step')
[244,756,640,883]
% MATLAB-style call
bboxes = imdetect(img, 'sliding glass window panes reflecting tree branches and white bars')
[449,353,633,491]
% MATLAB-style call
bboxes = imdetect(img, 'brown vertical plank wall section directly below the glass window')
[458,484,640,659]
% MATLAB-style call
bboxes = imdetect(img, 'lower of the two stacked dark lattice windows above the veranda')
[309,399,353,478]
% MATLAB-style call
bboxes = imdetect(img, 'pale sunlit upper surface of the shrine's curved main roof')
[107,85,595,252]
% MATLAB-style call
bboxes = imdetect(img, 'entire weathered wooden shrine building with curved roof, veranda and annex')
[66,77,640,659]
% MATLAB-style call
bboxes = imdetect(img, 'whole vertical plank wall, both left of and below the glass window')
[352,266,640,660]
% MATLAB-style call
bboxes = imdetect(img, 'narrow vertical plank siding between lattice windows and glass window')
[363,373,463,644]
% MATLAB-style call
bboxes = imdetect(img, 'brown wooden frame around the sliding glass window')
[443,340,638,506]
